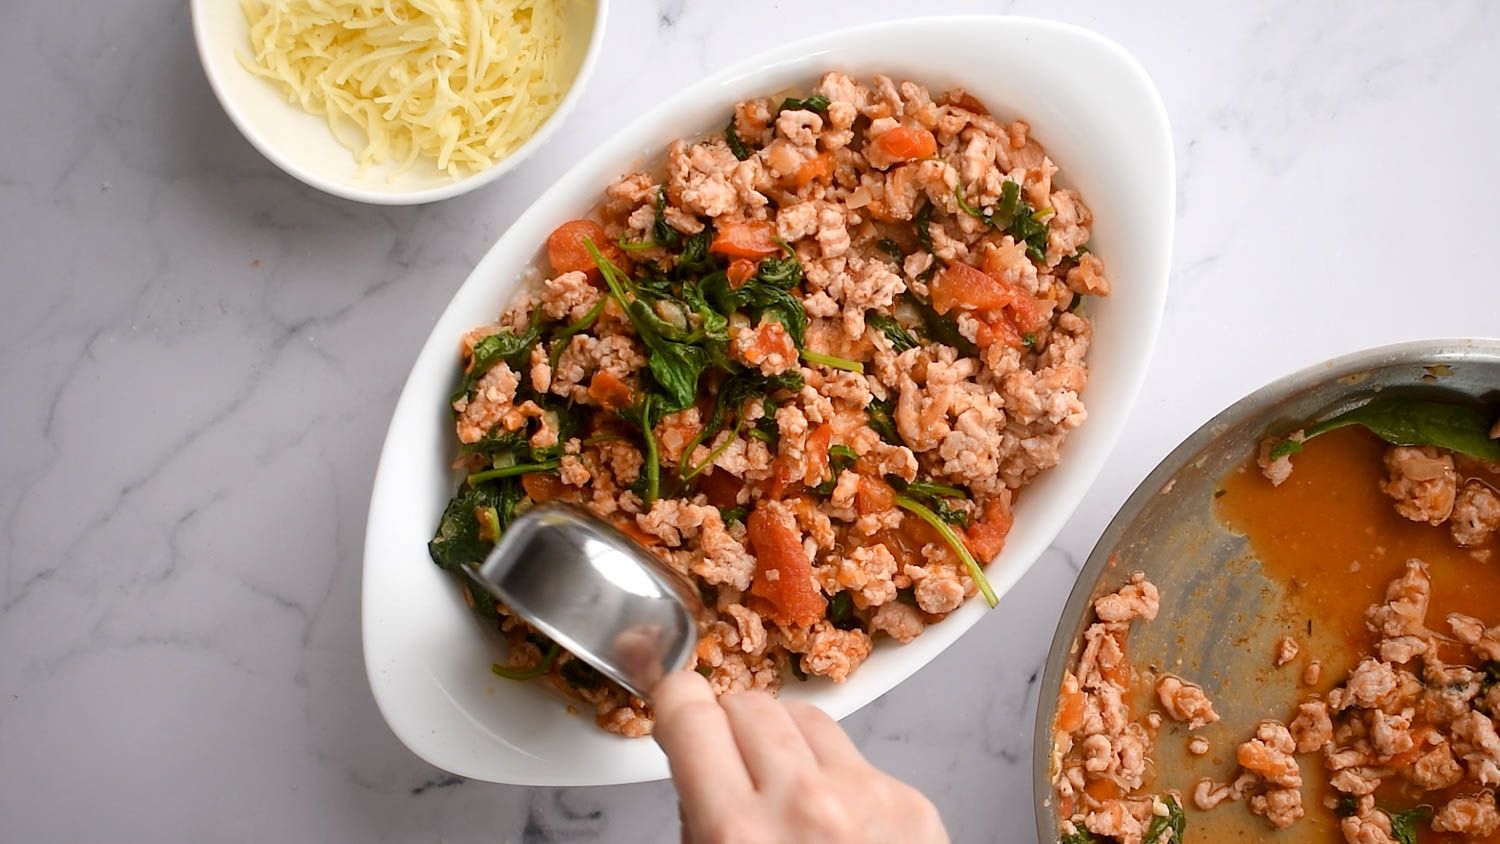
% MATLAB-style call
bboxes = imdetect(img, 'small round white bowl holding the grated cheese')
[192,0,609,205]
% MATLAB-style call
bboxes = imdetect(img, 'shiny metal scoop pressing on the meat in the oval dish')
[465,502,702,700]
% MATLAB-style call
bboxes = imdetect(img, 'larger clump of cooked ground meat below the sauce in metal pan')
[1194,559,1500,844]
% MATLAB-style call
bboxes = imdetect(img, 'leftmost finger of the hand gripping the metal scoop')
[651,672,753,826]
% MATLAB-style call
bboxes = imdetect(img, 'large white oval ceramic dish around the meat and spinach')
[363,16,1175,786]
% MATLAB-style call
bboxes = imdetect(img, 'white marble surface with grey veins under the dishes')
[0,0,1500,843]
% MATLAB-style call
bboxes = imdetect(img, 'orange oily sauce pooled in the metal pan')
[1218,427,1500,843]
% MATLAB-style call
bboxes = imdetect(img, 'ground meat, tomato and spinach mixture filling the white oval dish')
[431,72,1109,736]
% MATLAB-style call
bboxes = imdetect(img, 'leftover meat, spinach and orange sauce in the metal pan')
[1053,397,1500,844]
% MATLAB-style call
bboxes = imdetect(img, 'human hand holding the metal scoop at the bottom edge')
[651,672,948,844]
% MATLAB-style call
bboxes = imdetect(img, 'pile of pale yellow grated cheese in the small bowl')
[240,0,572,177]
